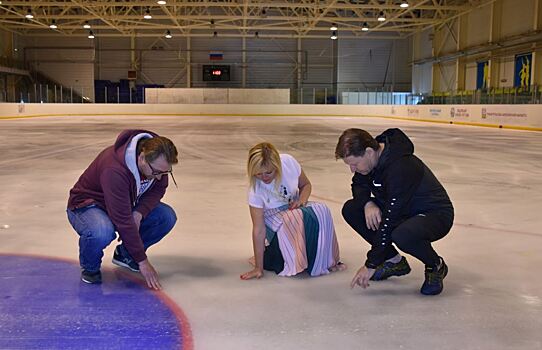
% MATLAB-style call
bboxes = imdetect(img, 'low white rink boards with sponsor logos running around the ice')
[0,103,542,131]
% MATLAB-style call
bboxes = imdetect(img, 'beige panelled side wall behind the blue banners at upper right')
[412,0,542,92]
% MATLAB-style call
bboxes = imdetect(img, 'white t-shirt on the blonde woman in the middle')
[248,154,301,209]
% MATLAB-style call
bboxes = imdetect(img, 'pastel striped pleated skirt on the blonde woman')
[264,202,339,276]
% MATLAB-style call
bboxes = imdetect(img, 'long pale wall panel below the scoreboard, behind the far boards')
[145,88,290,104]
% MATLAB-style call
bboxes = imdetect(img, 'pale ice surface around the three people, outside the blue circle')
[0,116,542,350]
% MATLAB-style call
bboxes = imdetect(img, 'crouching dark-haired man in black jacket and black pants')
[335,129,454,295]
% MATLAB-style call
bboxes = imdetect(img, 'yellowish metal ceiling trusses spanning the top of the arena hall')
[0,0,494,39]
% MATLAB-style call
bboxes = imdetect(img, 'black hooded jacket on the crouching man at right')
[352,129,453,268]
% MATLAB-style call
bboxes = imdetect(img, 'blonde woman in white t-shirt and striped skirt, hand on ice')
[241,142,346,280]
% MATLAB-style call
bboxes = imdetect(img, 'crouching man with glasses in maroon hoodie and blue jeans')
[67,130,178,289]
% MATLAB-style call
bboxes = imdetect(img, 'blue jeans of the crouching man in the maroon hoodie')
[67,203,177,272]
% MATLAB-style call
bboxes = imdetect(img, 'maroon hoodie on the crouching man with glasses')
[68,130,168,263]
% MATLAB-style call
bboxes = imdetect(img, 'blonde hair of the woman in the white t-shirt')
[247,142,282,188]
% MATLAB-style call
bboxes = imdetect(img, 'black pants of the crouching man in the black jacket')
[342,199,454,266]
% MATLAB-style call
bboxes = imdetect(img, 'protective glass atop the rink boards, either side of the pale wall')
[0,84,542,105]
